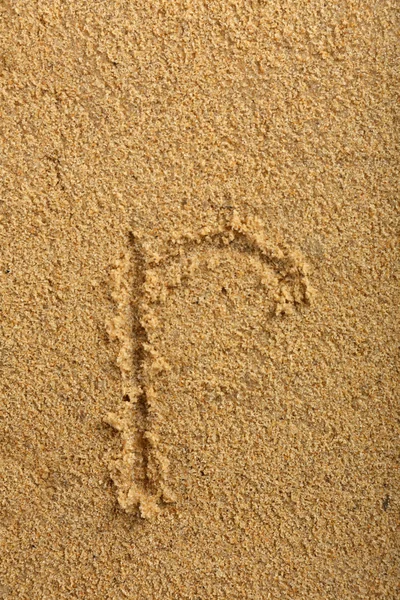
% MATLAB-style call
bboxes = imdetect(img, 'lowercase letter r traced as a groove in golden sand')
[106,213,312,518]
